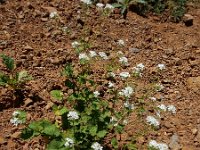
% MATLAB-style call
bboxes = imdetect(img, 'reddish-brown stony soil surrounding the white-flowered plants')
[0,0,200,150]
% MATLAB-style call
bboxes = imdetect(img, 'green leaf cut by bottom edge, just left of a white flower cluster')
[47,139,66,150]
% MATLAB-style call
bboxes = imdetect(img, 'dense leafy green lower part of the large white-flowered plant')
[22,61,133,150]
